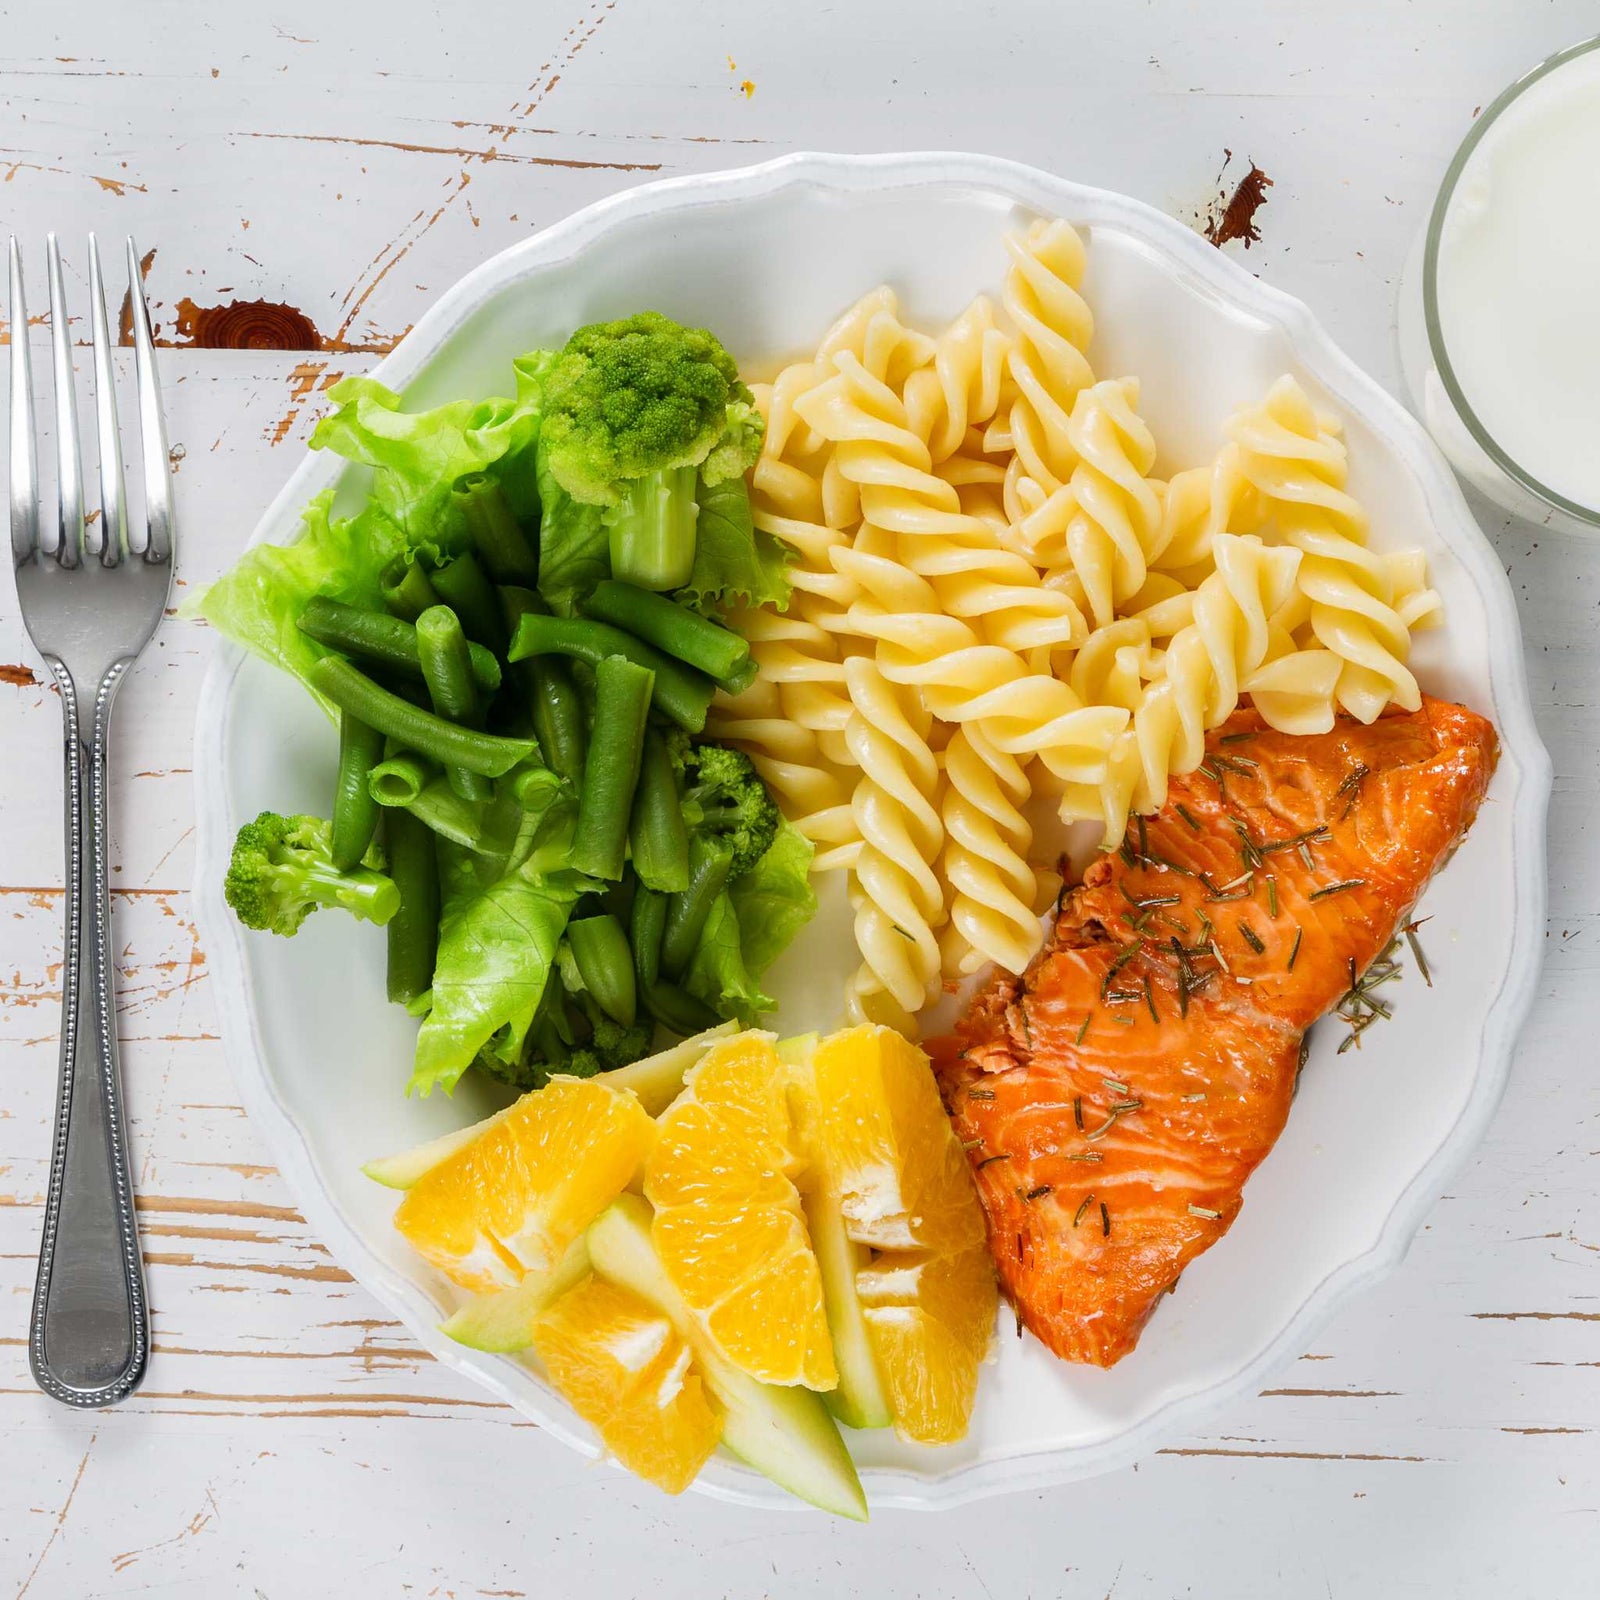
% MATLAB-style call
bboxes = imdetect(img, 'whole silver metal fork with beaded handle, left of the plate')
[11,234,173,1406]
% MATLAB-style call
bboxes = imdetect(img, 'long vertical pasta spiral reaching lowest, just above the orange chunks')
[845,656,944,1027]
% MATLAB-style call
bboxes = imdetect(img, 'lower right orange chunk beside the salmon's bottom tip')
[856,1245,997,1445]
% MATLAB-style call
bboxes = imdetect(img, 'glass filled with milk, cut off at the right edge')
[1400,38,1600,533]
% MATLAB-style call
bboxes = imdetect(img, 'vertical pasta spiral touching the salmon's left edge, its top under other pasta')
[941,725,1043,974]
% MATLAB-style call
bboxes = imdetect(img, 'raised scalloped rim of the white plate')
[194,152,1552,1510]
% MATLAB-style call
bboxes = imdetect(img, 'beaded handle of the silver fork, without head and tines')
[27,659,150,1406]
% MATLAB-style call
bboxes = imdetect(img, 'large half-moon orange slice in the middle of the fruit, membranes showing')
[645,1034,838,1389]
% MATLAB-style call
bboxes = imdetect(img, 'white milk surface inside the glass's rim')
[1437,50,1600,510]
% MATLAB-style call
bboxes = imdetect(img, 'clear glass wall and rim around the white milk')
[1398,35,1600,533]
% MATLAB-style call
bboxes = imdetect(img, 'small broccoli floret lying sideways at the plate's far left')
[222,811,400,936]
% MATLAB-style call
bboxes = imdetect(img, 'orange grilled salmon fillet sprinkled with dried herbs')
[930,699,1496,1366]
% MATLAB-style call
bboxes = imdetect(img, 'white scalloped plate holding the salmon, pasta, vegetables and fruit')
[195,155,1550,1507]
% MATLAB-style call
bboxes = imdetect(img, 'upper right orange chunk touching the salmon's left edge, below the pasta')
[811,1027,984,1250]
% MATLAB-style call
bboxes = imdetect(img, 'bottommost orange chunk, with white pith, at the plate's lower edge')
[533,1278,722,1494]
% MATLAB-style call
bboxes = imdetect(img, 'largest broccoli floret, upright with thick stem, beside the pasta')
[539,310,765,589]
